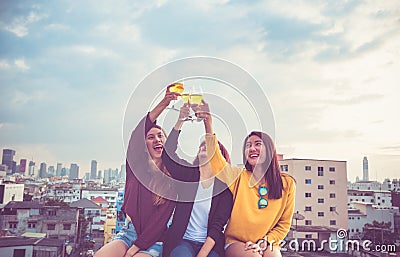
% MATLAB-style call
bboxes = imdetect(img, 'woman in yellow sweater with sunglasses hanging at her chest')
[192,101,296,257]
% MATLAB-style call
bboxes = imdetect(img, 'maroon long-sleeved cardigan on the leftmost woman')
[122,114,175,249]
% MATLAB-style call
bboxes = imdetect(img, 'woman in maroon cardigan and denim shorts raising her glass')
[95,86,179,257]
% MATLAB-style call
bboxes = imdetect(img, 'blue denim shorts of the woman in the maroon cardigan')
[112,218,163,257]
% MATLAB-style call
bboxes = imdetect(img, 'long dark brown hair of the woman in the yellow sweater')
[243,131,283,199]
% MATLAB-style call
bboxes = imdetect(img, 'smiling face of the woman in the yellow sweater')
[245,135,267,169]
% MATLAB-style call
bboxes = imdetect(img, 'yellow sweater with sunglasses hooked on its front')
[206,135,296,244]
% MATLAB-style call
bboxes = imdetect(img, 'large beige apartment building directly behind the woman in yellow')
[279,159,348,238]
